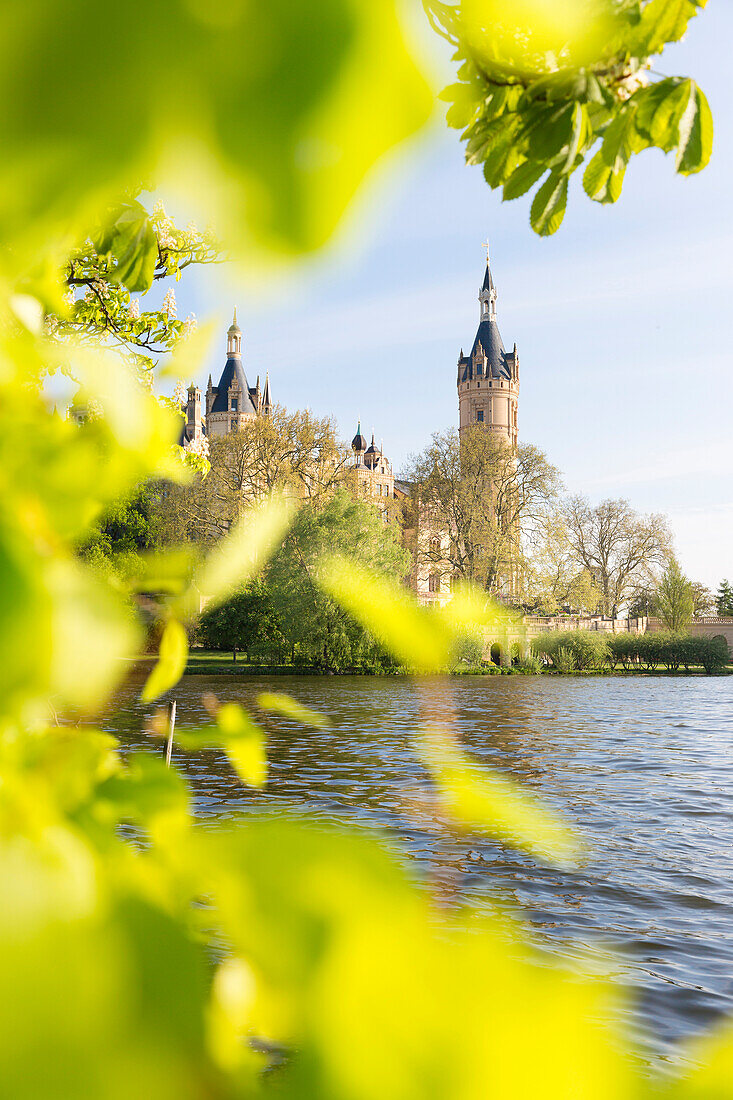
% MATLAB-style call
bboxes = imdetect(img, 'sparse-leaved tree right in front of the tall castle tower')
[405,425,559,593]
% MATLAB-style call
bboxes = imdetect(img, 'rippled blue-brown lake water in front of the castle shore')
[106,675,733,1062]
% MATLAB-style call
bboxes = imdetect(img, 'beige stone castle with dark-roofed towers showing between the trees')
[182,253,519,604]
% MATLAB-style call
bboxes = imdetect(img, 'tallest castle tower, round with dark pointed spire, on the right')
[458,245,519,447]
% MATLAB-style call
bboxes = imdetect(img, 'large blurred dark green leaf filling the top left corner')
[0,0,431,273]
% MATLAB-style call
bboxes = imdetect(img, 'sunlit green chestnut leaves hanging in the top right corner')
[425,0,713,237]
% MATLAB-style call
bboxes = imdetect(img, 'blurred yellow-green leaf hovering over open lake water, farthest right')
[417,730,581,866]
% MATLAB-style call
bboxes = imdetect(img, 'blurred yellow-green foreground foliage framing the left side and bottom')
[0,0,732,1100]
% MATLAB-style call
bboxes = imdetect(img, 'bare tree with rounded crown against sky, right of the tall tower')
[565,496,672,618]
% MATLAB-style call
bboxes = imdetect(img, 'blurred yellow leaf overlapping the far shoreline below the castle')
[318,557,451,672]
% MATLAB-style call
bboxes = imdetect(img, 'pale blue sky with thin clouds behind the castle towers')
[168,0,733,586]
